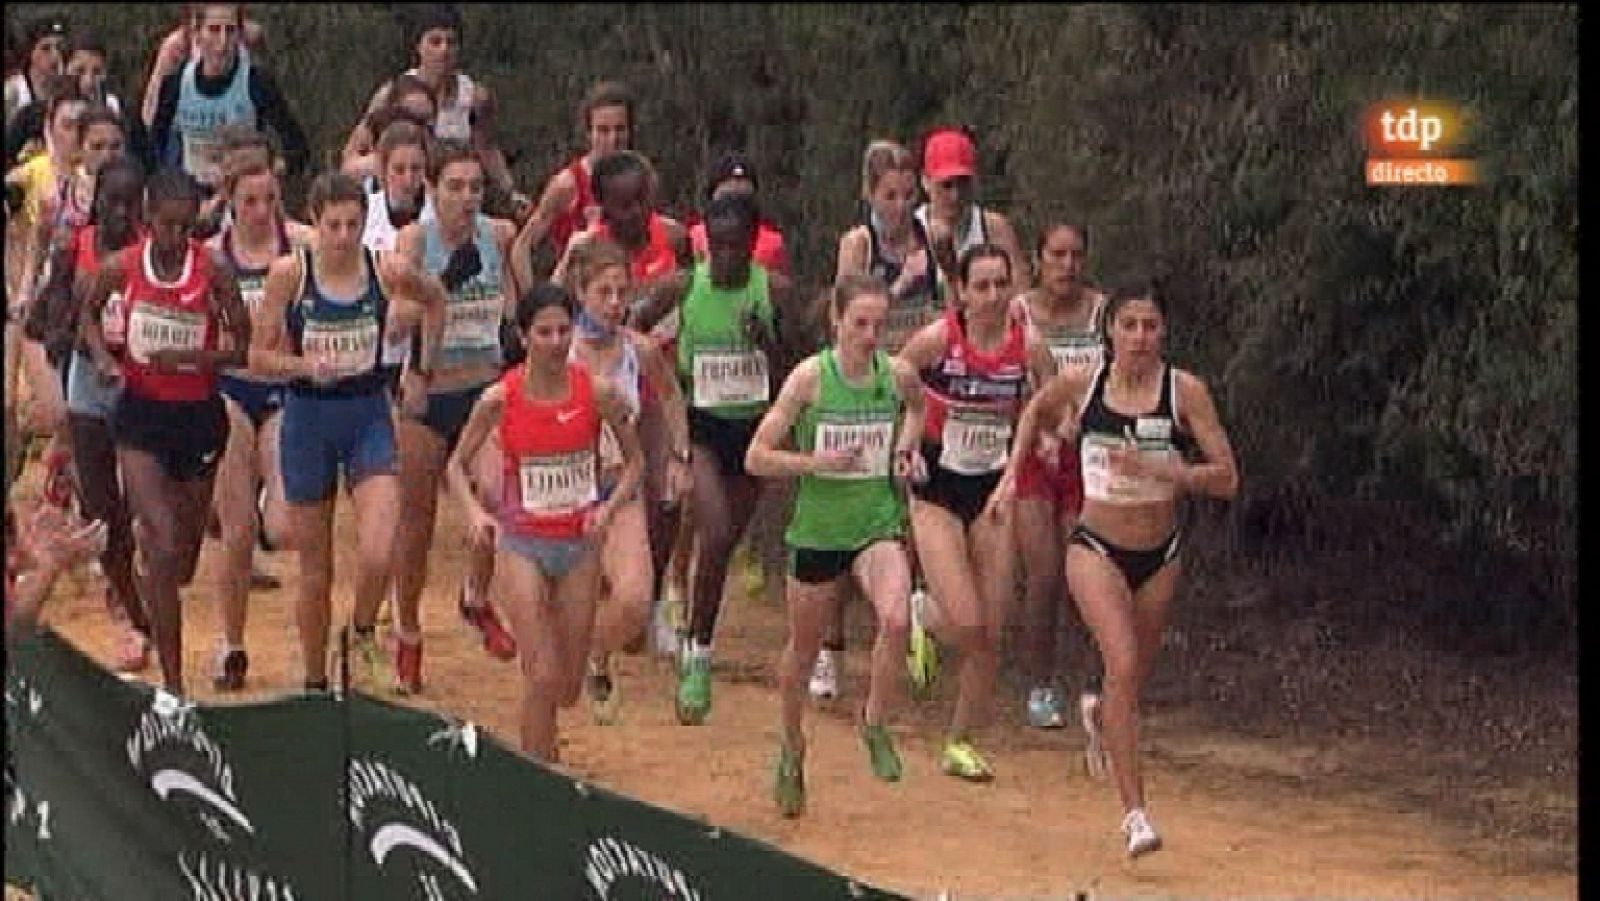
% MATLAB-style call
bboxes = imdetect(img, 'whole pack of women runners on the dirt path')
[6,3,1238,855]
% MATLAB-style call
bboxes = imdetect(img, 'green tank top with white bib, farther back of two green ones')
[677,262,773,419]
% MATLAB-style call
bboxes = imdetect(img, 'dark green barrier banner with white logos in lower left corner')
[5,631,898,901]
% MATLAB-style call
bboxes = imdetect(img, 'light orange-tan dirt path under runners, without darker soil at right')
[37,504,1578,898]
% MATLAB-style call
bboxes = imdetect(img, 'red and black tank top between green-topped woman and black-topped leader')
[922,309,1027,475]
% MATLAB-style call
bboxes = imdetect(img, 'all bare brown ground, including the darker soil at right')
[18,504,1578,898]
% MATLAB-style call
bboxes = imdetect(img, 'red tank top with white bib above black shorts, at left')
[120,237,218,400]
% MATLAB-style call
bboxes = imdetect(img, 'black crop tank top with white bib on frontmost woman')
[1078,363,1194,504]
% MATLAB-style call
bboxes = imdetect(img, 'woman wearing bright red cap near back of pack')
[917,128,1029,291]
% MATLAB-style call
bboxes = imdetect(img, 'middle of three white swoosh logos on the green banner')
[349,758,478,901]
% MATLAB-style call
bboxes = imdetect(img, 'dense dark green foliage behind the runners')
[6,3,1578,608]
